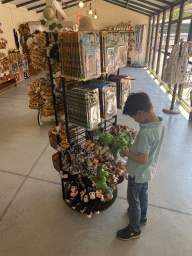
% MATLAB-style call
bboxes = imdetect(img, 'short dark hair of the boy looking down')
[123,92,153,116]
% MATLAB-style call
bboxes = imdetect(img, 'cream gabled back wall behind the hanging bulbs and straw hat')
[64,0,149,64]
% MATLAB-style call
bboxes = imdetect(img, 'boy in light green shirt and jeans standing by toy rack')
[117,92,165,240]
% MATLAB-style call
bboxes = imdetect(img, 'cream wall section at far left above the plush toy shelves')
[0,2,42,54]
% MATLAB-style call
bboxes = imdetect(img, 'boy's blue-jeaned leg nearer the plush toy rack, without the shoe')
[127,176,143,231]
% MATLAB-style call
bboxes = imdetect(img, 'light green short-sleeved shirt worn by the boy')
[126,117,165,183]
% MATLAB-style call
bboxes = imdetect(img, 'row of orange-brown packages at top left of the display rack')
[58,31,101,80]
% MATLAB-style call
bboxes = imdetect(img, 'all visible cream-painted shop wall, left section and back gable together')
[0,0,149,63]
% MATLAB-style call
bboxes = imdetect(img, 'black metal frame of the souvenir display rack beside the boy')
[46,33,120,214]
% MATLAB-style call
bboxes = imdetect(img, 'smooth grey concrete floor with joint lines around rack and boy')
[0,68,192,256]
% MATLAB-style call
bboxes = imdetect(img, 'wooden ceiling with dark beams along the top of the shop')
[1,0,185,16]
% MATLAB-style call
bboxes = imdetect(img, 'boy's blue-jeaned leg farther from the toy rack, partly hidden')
[139,182,148,219]
